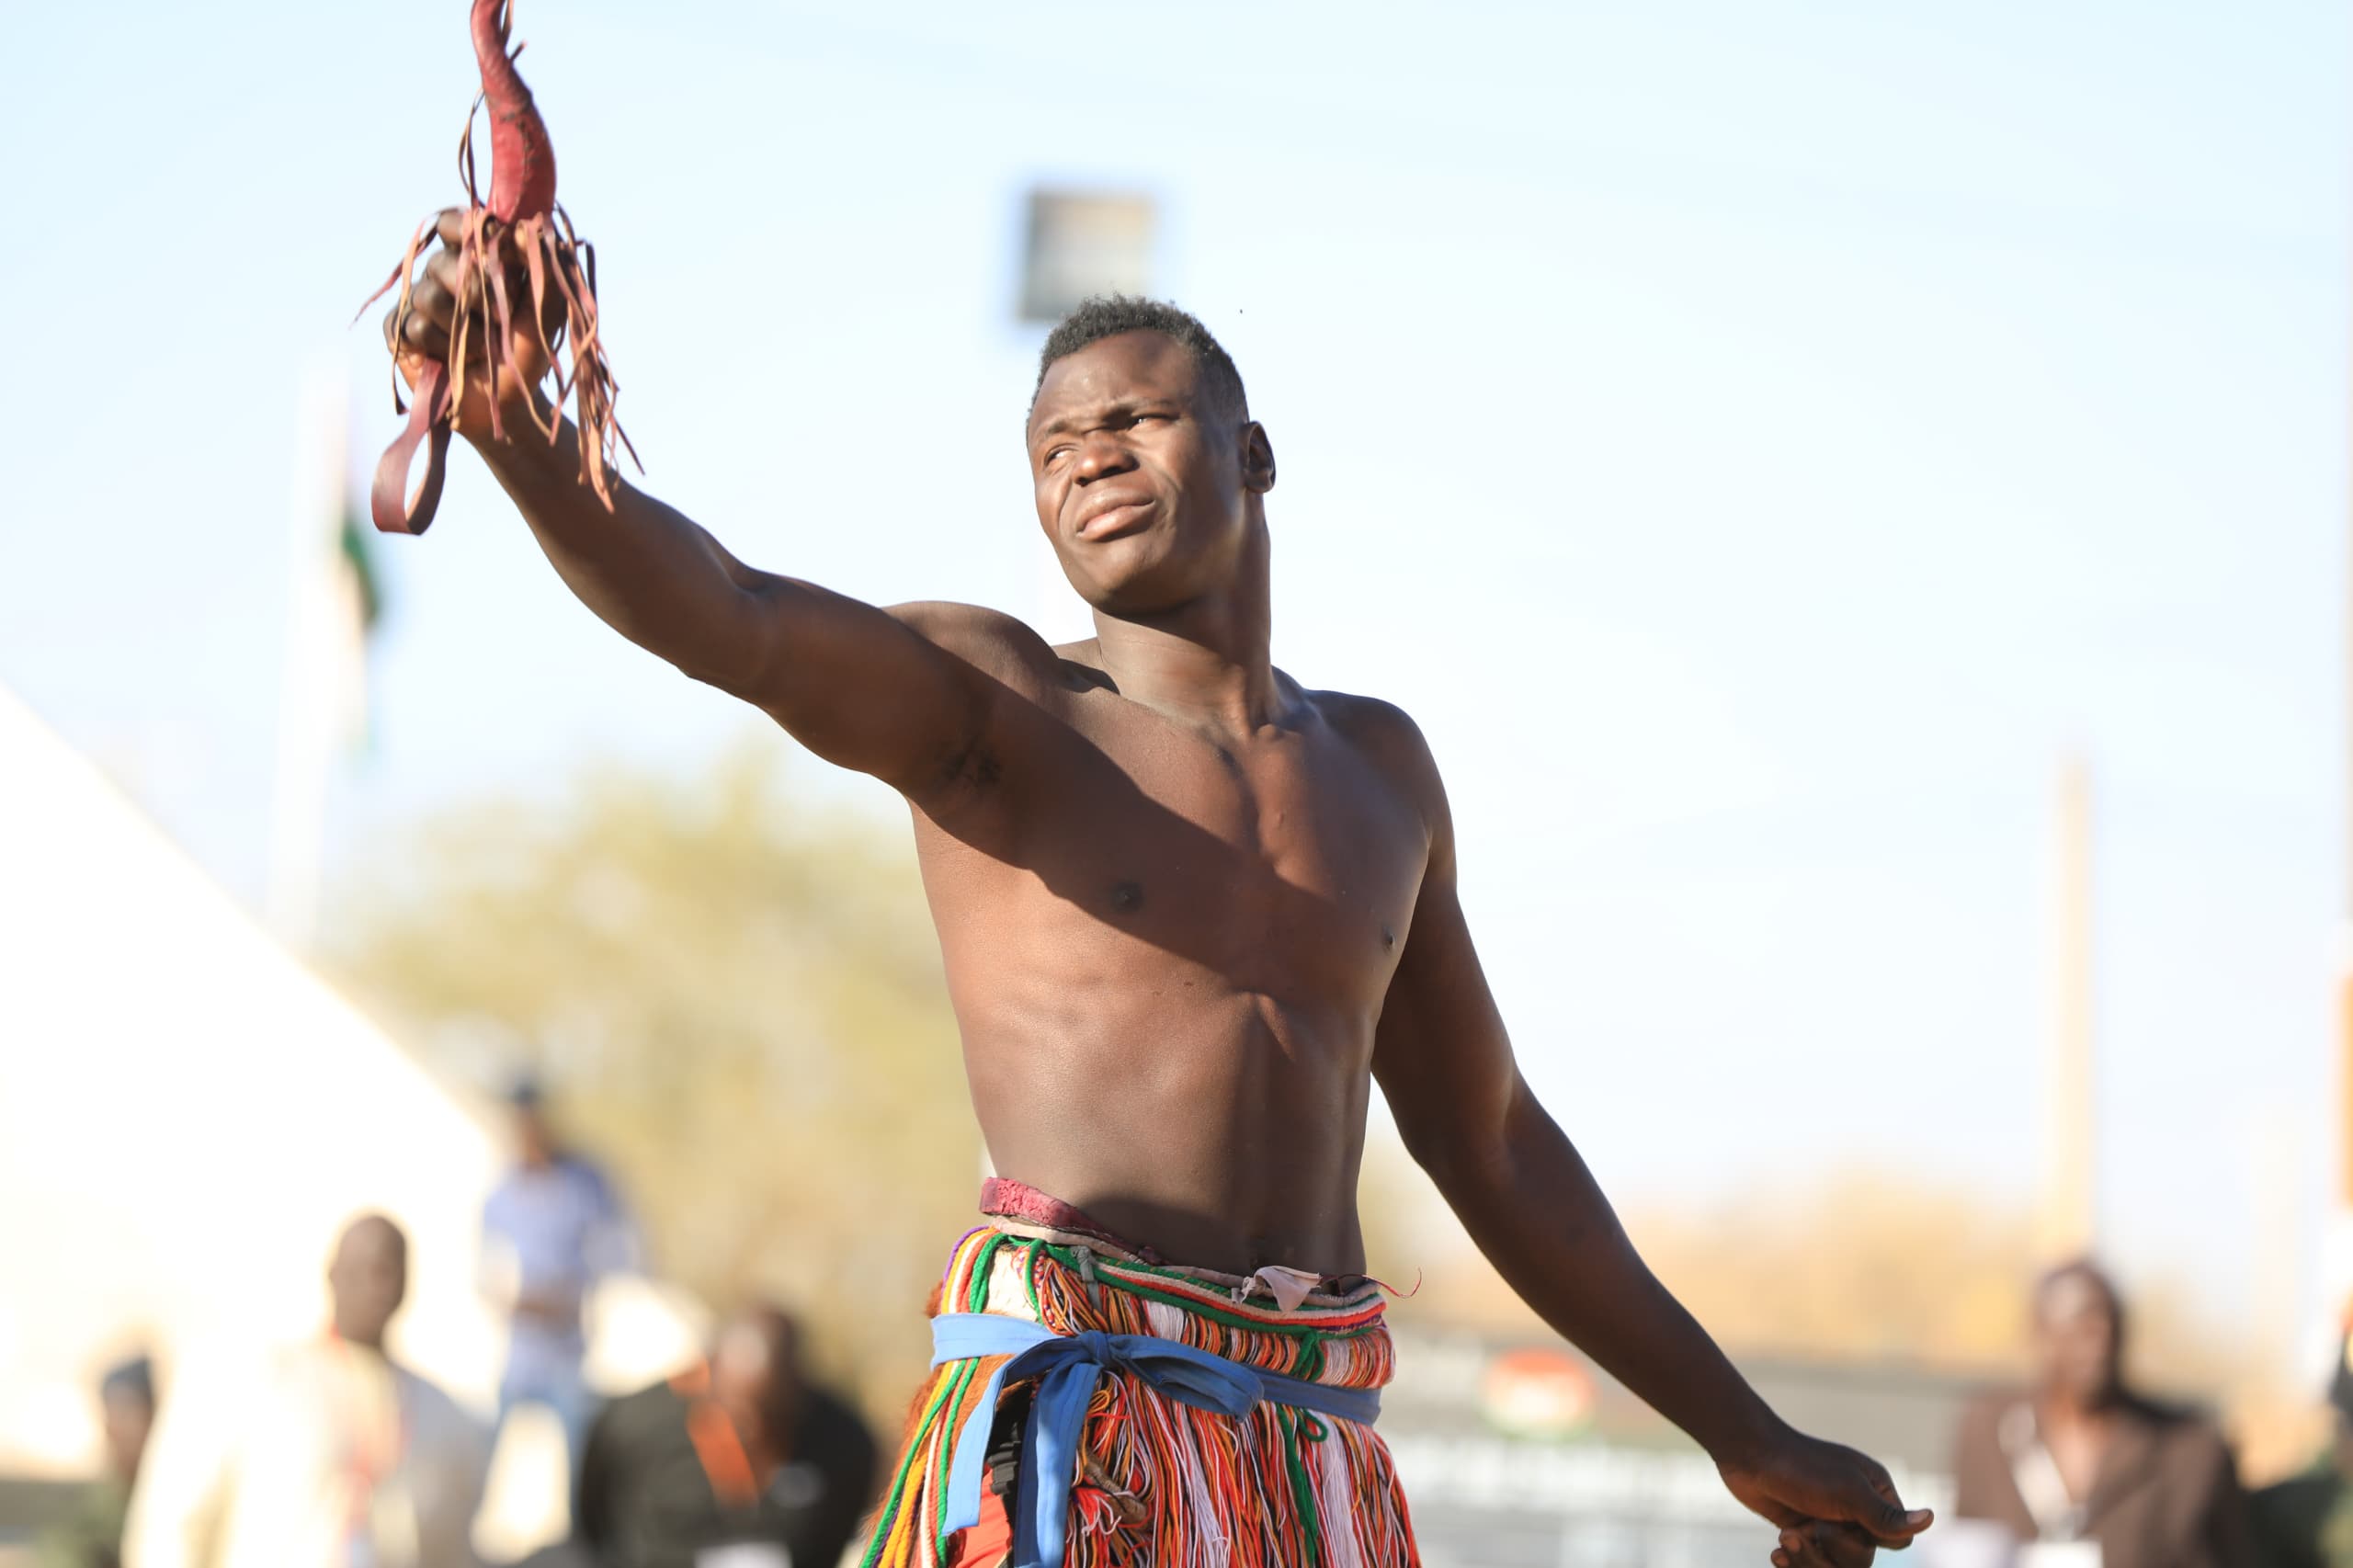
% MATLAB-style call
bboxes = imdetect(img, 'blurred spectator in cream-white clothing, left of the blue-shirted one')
[122,1215,489,1568]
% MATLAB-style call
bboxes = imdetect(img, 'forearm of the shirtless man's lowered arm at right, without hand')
[1440,1085,1783,1464]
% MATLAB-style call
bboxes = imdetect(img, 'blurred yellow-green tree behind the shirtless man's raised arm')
[335,744,982,1420]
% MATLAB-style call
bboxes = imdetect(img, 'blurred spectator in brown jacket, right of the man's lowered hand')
[1953,1262,2254,1568]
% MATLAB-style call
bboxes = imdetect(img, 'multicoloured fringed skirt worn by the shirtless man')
[861,1227,1419,1568]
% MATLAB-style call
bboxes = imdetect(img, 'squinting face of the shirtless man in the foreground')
[1029,332,1273,615]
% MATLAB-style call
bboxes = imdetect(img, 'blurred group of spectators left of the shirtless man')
[35,1083,875,1568]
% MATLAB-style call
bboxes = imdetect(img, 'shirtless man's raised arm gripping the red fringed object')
[386,214,1000,796]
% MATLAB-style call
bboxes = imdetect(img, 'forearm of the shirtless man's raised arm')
[475,410,756,687]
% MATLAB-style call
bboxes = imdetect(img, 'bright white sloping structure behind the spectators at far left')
[0,690,501,1474]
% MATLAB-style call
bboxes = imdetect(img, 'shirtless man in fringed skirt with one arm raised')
[386,214,1929,1568]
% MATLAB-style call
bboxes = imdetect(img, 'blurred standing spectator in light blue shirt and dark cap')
[483,1078,635,1474]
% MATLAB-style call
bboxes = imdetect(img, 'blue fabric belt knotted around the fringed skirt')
[932,1312,1381,1568]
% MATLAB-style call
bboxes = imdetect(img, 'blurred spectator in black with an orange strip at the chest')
[564,1309,875,1568]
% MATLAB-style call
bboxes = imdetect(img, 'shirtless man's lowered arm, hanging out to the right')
[1374,734,1927,1568]
